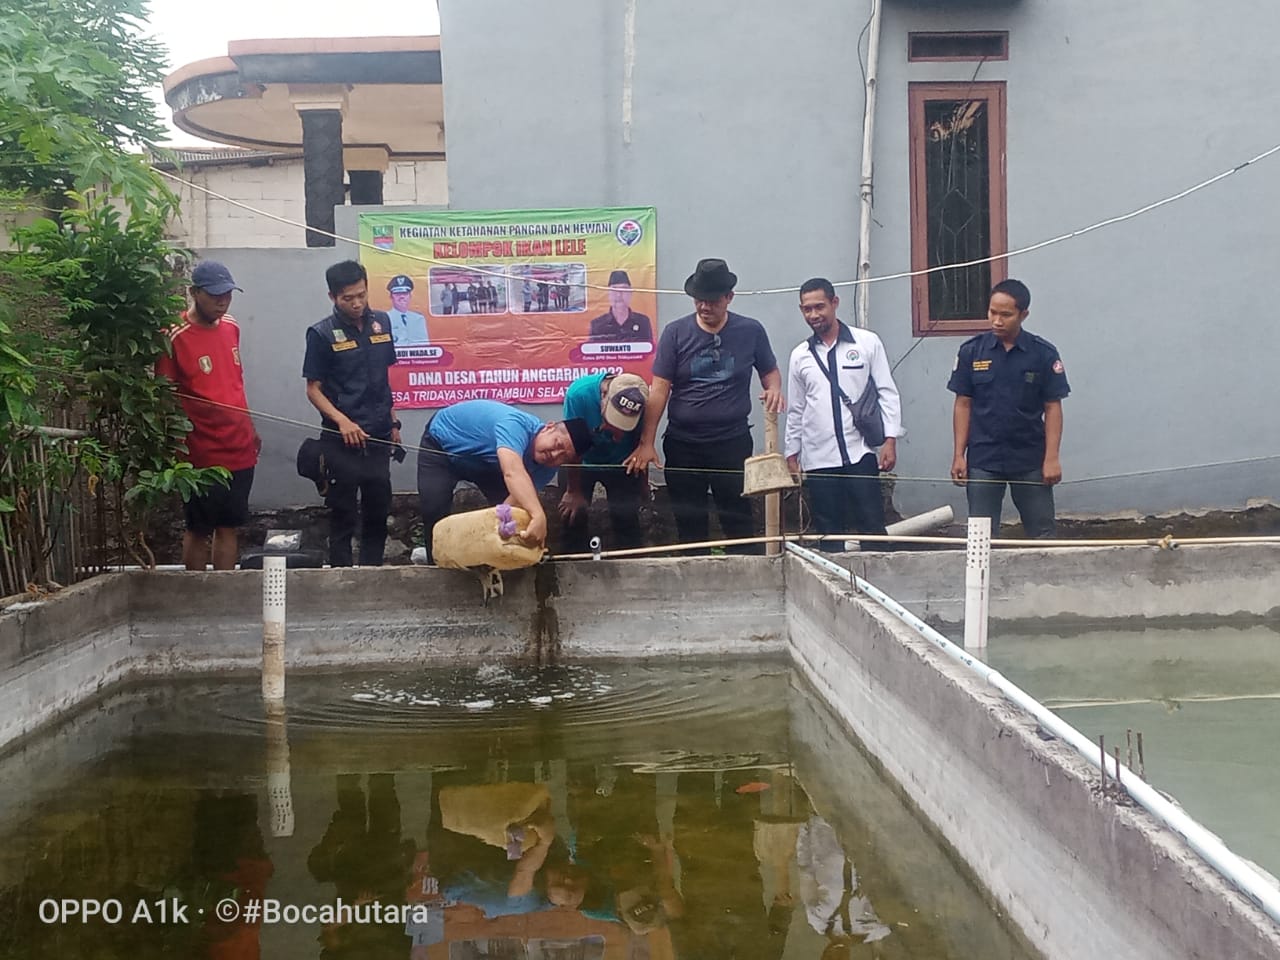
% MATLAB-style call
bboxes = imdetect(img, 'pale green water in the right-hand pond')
[986,626,1280,876]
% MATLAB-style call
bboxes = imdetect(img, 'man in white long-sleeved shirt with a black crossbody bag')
[783,276,902,552]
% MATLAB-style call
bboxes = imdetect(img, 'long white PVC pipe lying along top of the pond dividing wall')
[787,543,1280,923]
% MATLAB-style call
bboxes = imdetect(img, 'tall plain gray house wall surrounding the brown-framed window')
[440,0,1280,516]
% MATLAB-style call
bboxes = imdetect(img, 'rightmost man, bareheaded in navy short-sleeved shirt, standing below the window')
[947,280,1071,539]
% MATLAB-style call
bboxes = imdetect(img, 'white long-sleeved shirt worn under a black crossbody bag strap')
[783,321,904,470]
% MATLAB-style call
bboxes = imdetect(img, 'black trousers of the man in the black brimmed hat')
[662,434,763,553]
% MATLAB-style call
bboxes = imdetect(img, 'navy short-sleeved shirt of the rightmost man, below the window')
[947,330,1071,475]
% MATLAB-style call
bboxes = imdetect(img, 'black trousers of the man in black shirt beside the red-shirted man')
[324,435,392,567]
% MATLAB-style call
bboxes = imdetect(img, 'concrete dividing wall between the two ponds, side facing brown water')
[786,557,1280,960]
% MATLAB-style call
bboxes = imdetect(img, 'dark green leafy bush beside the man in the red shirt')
[0,192,228,576]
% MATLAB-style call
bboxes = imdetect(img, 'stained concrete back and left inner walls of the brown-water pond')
[0,557,786,748]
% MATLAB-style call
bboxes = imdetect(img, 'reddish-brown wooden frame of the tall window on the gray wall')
[908,81,1009,337]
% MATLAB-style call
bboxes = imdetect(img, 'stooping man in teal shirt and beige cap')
[559,374,649,553]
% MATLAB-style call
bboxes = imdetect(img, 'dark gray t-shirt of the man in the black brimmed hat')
[653,314,778,443]
